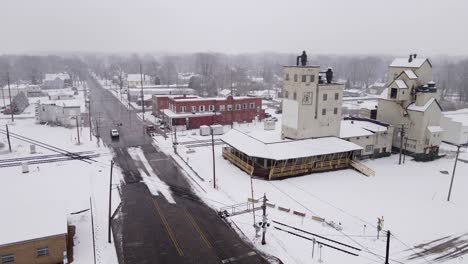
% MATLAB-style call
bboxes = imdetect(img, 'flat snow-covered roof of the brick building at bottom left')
[0,199,67,245]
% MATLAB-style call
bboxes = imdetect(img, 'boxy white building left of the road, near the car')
[37,100,82,127]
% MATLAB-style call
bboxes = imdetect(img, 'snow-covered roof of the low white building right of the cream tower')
[340,120,387,138]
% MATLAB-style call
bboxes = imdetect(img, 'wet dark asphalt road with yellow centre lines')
[87,79,267,264]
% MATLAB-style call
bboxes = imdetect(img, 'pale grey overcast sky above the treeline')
[0,0,468,55]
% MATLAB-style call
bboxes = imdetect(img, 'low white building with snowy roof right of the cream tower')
[340,118,393,158]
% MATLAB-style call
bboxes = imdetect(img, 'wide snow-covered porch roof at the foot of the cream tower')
[221,129,362,160]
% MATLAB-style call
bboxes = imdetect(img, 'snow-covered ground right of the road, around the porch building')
[152,109,468,264]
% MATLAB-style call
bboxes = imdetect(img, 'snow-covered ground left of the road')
[0,107,122,264]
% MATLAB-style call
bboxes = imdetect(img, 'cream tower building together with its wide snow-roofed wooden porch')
[222,52,374,180]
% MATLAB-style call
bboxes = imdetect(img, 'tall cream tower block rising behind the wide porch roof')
[282,66,344,139]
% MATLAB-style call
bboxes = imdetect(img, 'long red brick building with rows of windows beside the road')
[160,96,265,129]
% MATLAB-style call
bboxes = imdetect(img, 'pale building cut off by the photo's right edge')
[440,109,468,145]
